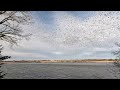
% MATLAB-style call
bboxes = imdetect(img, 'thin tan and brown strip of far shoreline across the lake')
[0,59,119,64]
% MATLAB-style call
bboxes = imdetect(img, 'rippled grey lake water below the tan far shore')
[1,63,118,79]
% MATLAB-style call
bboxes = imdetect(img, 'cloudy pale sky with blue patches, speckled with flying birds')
[3,11,120,60]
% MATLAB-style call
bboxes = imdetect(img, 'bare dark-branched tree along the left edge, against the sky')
[0,11,31,78]
